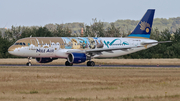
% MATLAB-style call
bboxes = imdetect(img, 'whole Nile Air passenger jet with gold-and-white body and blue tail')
[8,9,171,66]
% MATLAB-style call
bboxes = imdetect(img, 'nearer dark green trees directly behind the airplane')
[0,19,180,59]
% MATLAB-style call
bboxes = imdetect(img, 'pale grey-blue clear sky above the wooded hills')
[0,0,180,28]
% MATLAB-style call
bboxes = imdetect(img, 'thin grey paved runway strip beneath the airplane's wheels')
[0,64,180,68]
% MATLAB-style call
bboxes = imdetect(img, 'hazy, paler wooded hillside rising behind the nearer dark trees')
[41,17,180,34]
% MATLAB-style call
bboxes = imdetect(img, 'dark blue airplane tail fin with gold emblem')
[128,9,155,38]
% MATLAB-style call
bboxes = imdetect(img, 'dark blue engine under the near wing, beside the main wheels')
[67,53,87,63]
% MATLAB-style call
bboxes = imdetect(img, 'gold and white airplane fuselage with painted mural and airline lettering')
[8,37,157,58]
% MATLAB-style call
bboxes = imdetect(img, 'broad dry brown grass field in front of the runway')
[0,60,180,101]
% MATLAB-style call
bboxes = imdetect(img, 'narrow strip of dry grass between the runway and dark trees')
[0,58,180,65]
